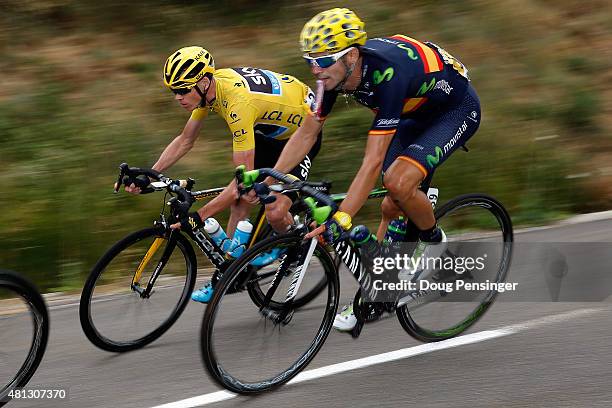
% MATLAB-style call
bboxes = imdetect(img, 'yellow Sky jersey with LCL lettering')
[191,67,315,151]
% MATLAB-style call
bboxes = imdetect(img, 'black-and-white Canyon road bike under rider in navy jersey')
[201,169,513,394]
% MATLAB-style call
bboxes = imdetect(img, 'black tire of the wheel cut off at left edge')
[0,269,49,406]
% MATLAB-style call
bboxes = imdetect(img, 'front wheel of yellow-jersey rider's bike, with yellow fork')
[79,227,196,352]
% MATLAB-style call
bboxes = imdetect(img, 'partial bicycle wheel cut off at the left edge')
[0,270,49,406]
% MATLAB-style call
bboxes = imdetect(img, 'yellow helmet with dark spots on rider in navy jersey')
[300,8,368,53]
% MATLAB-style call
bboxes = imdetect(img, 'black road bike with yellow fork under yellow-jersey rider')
[79,163,326,352]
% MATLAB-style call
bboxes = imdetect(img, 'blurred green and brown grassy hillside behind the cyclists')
[0,0,612,291]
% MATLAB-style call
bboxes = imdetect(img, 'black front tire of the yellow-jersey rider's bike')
[79,227,197,353]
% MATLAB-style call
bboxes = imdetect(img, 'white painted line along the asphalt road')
[147,308,604,408]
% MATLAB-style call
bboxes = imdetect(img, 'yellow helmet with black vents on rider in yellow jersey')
[164,47,215,89]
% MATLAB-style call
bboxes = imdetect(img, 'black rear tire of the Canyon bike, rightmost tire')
[396,193,514,342]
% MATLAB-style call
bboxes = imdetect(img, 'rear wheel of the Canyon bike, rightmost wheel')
[396,194,513,342]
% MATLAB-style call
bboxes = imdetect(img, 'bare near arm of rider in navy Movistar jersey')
[340,134,393,217]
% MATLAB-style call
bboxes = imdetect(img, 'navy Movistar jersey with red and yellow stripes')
[320,35,469,136]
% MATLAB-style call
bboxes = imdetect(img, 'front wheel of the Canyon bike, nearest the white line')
[201,233,339,394]
